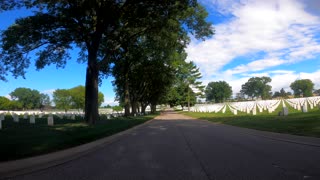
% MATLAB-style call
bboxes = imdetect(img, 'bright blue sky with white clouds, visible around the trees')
[0,0,320,104]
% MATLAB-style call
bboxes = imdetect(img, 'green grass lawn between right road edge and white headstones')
[183,105,320,138]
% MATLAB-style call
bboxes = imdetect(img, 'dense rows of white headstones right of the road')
[190,96,320,116]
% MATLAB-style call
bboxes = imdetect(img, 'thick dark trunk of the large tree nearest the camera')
[85,52,99,124]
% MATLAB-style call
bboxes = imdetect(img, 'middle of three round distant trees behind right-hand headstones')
[240,76,271,99]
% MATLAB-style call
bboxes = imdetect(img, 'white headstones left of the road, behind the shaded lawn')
[0,111,149,129]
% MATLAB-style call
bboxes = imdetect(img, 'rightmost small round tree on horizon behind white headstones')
[290,79,314,97]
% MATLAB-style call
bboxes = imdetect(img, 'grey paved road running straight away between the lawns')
[5,112,320,180]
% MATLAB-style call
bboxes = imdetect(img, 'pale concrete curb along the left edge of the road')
[0,119,154,179]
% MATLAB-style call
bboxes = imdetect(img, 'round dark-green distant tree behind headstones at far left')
[10,87,40,109]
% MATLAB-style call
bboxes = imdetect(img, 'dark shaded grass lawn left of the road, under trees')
[0,112,156,161]
